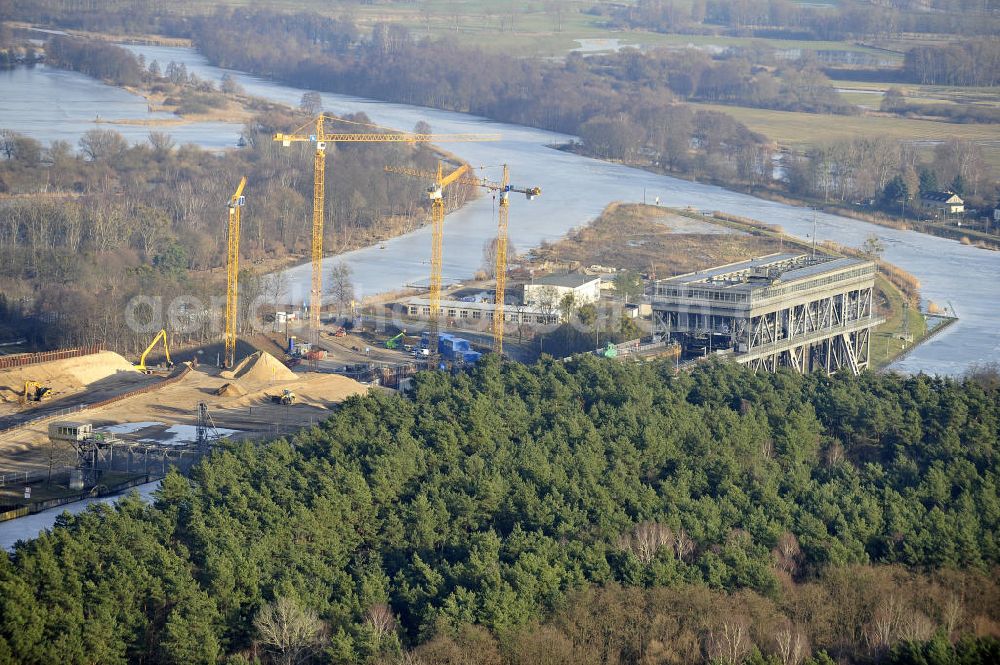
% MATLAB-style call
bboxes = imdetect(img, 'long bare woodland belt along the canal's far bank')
[186,10,832,188]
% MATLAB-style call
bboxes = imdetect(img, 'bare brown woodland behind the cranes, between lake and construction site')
[0,112,436,352]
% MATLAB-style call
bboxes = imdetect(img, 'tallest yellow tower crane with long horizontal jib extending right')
[274,114,500,341]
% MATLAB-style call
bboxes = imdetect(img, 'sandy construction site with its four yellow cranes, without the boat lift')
[0,114,516,519]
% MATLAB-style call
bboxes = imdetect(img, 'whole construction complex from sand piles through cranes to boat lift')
[0,115,936,519]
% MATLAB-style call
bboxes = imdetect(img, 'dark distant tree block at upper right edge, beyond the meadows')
[904,36,1000,86]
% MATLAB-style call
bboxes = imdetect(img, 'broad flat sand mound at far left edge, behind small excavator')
[0,351,144,401]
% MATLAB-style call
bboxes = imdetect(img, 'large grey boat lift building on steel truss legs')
[652,254,881,374]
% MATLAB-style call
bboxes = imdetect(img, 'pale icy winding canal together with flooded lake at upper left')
[0,46,1000,547]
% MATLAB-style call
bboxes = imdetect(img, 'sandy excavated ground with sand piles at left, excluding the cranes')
[0,342,367,505]
